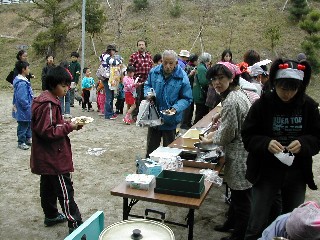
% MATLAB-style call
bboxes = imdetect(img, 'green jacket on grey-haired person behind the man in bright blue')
[192,63,209,104]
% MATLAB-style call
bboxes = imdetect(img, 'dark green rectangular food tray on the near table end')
[154,170,205,198]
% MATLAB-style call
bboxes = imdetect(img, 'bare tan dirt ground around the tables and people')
[0,91,320,240]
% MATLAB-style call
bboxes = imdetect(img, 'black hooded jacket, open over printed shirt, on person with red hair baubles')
[241,92,320,190]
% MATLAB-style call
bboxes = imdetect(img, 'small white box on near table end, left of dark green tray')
[126,174,155,190]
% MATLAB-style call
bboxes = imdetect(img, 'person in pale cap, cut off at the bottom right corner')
[258,201,320,240]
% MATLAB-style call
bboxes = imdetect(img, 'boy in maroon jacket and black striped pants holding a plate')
[30,66,82,233]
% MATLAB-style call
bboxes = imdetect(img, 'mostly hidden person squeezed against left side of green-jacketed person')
[180,54,199,129]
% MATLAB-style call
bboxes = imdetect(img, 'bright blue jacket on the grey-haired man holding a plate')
[144,64,192,130]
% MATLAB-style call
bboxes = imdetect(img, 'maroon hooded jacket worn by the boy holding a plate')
[30,91,74,175]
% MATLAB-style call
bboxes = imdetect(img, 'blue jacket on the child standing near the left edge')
[12,75,33,122]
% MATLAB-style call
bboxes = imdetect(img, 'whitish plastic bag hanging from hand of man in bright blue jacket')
[136,100,163,127]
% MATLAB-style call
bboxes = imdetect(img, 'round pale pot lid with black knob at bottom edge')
[99,219,175,240]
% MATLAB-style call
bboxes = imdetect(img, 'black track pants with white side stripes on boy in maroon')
[40,173,82,228]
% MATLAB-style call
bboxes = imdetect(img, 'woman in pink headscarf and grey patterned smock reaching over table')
[201,62,252,240]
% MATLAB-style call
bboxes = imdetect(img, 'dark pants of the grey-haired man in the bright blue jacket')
[146,127,176,158]
